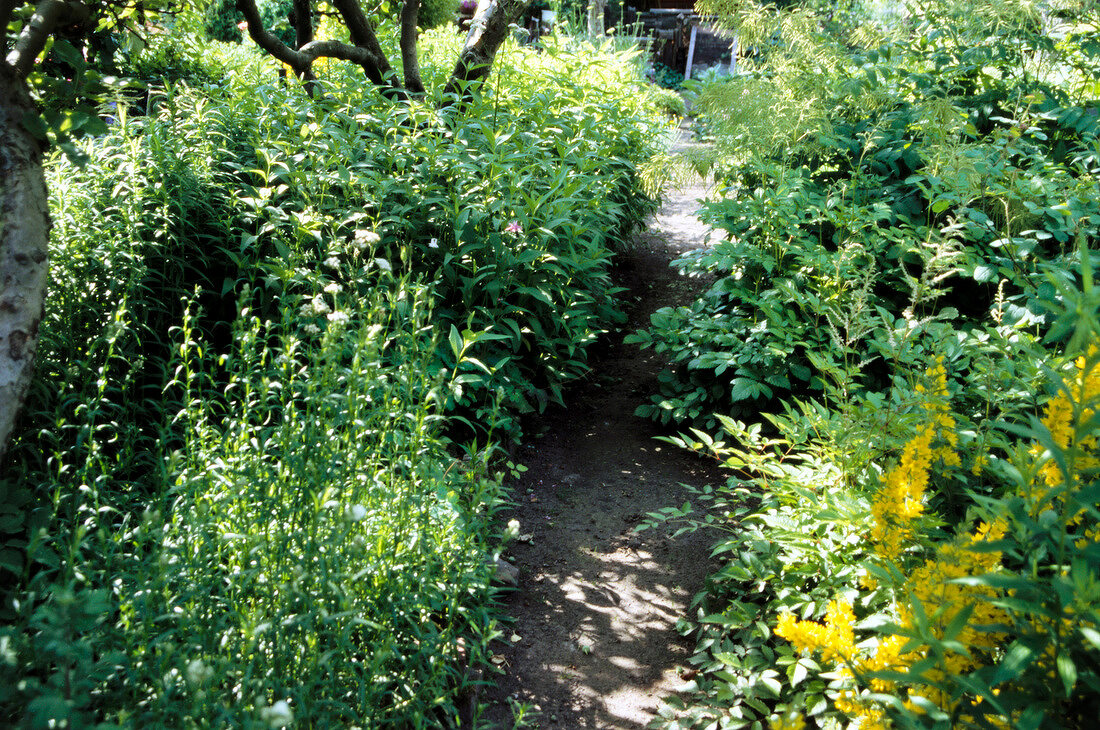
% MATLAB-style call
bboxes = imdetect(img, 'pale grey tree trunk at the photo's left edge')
[0,63,50,460]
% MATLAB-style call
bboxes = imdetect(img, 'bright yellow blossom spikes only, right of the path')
[776,349,1100,730]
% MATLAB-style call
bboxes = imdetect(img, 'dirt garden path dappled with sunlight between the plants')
[481,132,724,730]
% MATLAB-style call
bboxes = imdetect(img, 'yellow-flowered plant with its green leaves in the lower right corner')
[776,347,1100,728]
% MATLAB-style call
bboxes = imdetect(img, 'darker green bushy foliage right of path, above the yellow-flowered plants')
[635,0,1100,425]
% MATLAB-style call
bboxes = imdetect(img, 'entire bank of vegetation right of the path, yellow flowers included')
[635,2,1100,728]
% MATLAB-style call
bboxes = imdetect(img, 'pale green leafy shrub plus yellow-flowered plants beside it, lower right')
[650,295,1100,728]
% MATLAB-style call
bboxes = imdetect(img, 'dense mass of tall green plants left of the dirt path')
[0,17,663,728]
